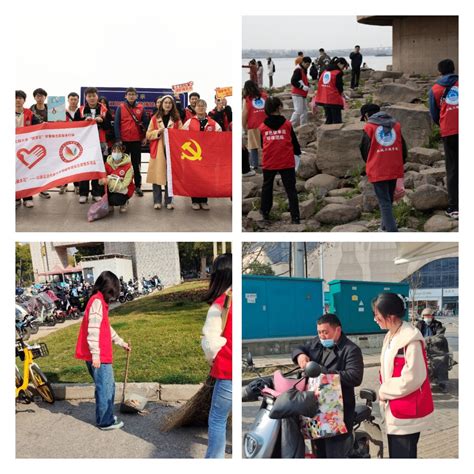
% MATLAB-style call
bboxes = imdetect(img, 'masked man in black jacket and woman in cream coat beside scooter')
[292,293,434,458]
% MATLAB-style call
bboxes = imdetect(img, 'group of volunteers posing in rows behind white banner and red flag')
[15,87,232,212]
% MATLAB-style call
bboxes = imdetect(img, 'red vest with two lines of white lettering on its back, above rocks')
[258,120,295,170]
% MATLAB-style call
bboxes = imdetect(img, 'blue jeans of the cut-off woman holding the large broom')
[205,379,232,458]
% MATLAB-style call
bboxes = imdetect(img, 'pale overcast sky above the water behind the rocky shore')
[242,16,392,51]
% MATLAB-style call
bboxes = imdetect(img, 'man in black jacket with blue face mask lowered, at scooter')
[292,313,364,458]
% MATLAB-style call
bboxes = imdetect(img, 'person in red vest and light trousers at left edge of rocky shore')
[242,81,268,170]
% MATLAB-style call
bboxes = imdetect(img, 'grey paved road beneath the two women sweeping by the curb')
[16,400,231,458]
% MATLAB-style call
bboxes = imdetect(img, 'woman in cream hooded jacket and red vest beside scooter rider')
[373,293,434,458]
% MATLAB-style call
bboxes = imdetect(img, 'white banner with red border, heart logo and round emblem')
[15,121,106,199]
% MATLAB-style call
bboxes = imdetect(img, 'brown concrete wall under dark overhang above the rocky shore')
[392,16,458,75]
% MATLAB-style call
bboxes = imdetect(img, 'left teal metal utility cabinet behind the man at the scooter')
[242,275,323,340]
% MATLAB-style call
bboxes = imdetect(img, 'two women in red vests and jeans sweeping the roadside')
[75,253,232,458]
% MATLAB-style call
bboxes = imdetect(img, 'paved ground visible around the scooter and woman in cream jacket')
[242,318,459,459]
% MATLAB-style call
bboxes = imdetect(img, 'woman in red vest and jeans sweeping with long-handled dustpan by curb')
[75,271,132,430]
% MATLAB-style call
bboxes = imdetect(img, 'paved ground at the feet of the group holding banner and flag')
[16,190,232,232]
